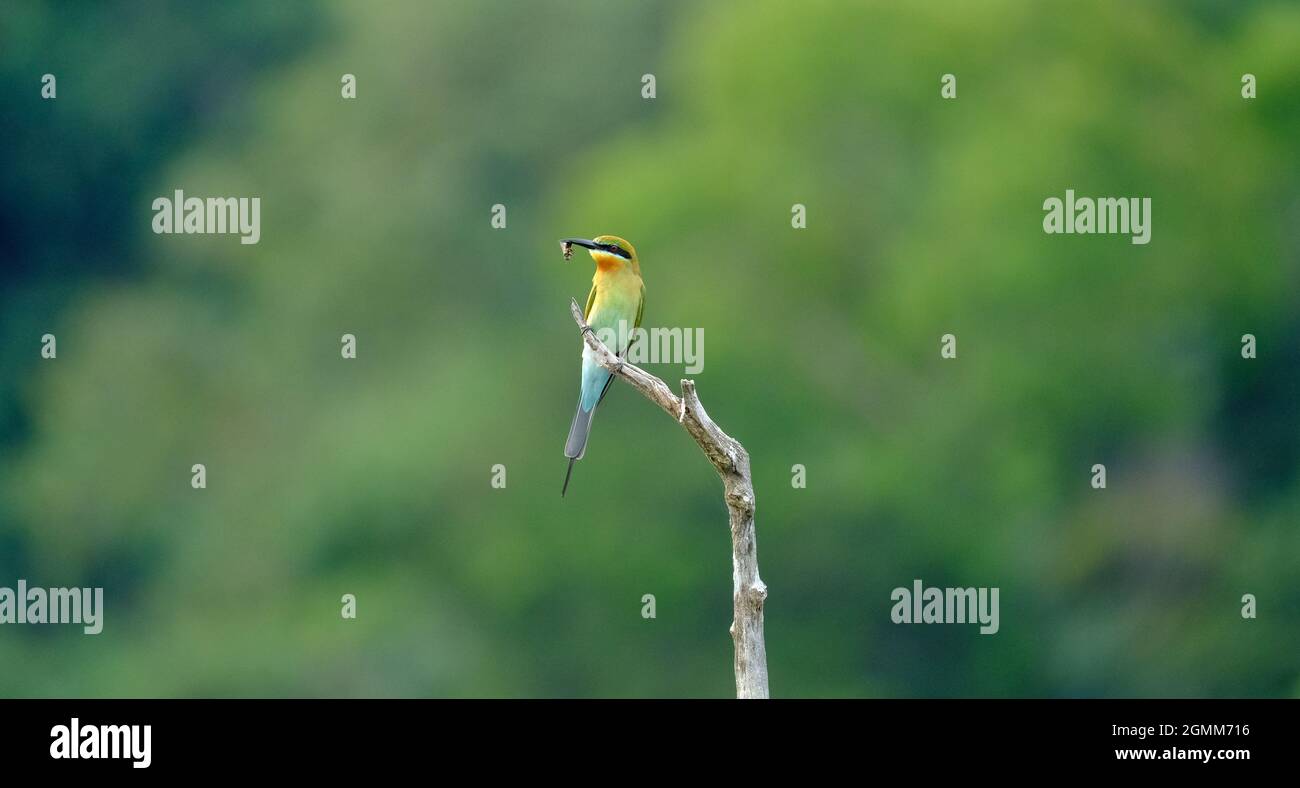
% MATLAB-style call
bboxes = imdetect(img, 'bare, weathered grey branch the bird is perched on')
[571,300,767,698]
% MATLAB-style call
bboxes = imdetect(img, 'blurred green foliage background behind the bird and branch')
[0,0,1300,696]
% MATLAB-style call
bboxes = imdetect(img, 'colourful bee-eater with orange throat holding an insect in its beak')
[560,235,646,497]
